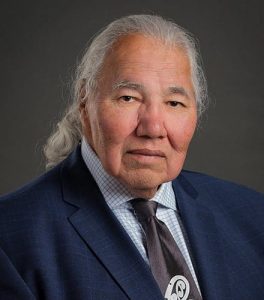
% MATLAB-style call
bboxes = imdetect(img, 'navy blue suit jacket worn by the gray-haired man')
[0,148,264,300]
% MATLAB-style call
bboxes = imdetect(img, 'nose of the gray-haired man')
[136,104,166,139]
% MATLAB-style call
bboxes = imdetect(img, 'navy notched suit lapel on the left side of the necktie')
[61,149,163,300]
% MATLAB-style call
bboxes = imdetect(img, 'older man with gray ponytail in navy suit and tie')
[0,15,264,300]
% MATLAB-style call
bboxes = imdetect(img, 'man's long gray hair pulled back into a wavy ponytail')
[44,15,207,168]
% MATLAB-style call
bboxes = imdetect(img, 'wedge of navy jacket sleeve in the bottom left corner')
[0,248,36,300]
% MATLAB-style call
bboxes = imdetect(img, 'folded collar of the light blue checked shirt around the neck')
[81,138,176,210]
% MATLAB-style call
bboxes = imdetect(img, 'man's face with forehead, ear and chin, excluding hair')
[81,34,197,198]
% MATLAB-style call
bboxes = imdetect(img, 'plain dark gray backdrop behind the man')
[0,0,264,194]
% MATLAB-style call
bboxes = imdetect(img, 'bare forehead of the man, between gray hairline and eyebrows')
[99,34,191,92]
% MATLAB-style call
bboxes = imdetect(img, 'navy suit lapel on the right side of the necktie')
[173,175,230,300]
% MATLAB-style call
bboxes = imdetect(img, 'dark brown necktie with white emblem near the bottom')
[132,199,202,300]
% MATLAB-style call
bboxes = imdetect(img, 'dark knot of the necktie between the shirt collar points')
[132,198,158,220]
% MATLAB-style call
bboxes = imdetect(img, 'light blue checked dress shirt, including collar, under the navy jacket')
[81,139,199,288]
